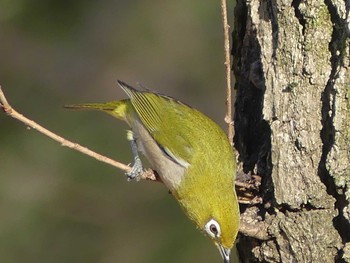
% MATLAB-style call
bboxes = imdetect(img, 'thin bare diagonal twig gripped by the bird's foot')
[0,86,157,181]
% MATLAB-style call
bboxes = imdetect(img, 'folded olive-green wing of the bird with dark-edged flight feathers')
[118,81,193,167]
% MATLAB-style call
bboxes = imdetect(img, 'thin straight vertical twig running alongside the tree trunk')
[221,0,234,145]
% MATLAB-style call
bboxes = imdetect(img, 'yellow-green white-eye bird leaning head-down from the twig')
[66,81,239,263]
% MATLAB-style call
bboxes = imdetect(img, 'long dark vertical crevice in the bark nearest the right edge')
[319,0,350,244]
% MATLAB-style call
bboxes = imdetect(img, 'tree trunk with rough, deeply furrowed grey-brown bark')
[233,0,350,262]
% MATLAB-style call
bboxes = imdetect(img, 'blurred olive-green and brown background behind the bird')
[0,0,234,263]
